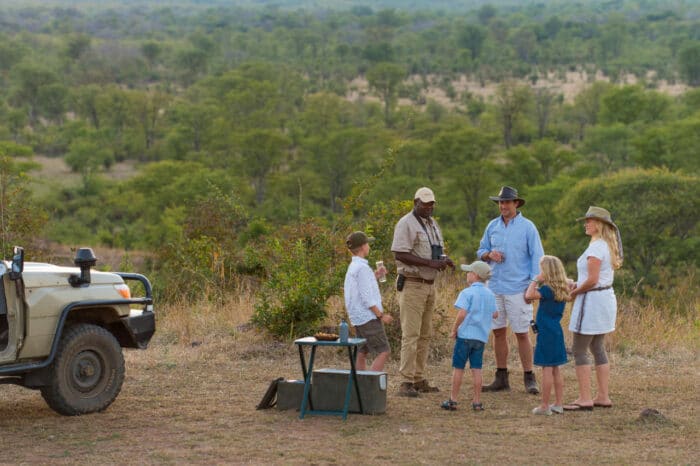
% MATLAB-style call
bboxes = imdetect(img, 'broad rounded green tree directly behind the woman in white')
[548,169,700,287]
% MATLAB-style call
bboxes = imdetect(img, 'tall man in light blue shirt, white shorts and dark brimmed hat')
[476,186,544,395]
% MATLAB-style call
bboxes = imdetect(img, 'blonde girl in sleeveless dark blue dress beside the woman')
[525,256,571,416]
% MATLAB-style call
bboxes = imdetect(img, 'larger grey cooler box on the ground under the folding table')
[312,369,387,414]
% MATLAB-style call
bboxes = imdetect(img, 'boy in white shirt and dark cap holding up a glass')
[343,231,393,371]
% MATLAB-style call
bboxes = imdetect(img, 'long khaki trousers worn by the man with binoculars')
[399,281,435,383]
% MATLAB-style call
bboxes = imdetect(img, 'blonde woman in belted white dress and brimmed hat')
[564,206,623,411]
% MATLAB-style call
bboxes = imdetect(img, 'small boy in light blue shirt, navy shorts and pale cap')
[440,261,498,411]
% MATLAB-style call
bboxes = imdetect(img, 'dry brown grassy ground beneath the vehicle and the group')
[0,334,700,465]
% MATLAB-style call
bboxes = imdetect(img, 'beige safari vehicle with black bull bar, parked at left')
[0,247,155,416]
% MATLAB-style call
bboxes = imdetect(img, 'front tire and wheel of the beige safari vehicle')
[41,324,124,416]
